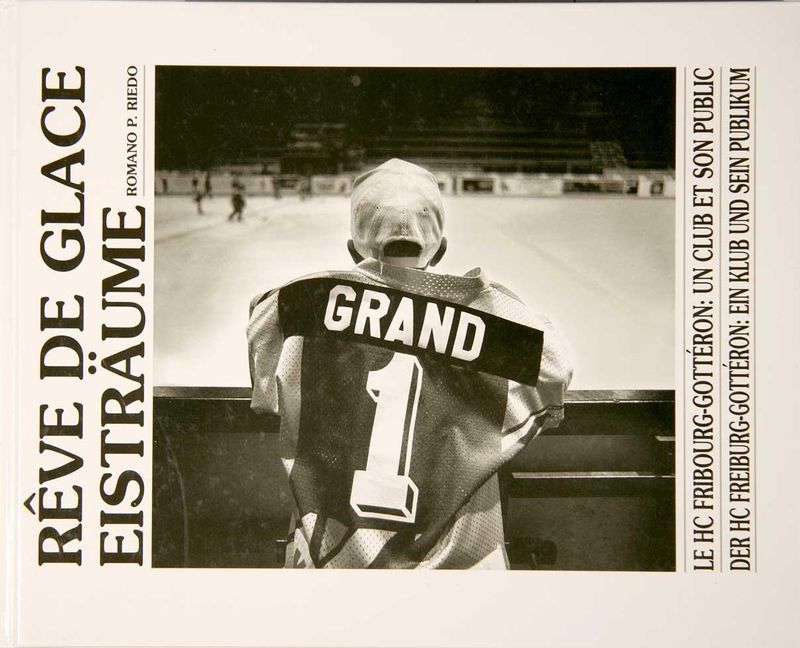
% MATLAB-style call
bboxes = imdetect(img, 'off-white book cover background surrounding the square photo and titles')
[0,2,800,648]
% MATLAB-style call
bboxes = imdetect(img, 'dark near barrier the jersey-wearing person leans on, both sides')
[152,387,675,571]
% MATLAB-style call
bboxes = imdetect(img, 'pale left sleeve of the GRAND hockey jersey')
[247,290,283,414]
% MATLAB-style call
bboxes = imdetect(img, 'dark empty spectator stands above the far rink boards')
[156,68,674,197]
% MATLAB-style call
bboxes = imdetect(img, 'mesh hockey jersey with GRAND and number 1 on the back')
[248,260,572,568]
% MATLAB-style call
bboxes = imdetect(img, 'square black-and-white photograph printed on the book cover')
[152,66,676,571]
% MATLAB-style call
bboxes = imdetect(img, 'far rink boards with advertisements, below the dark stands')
[155,169,675,198]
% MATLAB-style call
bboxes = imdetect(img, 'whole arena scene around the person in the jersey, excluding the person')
[152,66,676,571]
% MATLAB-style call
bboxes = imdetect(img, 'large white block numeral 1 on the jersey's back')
[350,353,422,523]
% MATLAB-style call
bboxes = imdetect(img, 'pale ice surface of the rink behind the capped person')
[154,196,675,389]
